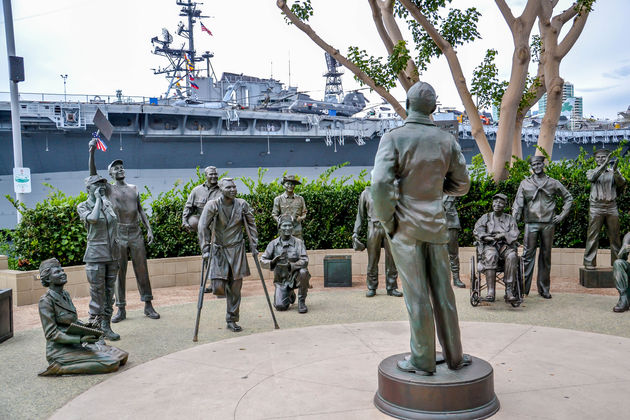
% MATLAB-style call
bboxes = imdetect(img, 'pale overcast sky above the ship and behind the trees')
[0,0,630,119]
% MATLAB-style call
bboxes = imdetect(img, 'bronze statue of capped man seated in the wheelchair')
[473,194,519,302]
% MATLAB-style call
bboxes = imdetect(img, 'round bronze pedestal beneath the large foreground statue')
[374,353,499,419]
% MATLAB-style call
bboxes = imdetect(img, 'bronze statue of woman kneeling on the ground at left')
[39,258,129,376]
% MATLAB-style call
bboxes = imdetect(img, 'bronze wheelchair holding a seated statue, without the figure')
[470,242,525,308]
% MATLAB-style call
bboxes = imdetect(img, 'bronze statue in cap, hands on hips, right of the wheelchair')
[512,156,573,299]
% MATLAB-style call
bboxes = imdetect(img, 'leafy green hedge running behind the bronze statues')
[0,147,630,270]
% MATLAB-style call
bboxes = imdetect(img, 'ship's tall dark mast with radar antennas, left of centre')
[151,0,214,99]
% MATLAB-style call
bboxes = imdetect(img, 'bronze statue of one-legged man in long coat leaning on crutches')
[199,178,258,332]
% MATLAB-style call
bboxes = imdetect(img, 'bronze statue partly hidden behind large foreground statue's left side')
[352,185,402,297]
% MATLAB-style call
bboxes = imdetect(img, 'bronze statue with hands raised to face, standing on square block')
[584,149,626,270]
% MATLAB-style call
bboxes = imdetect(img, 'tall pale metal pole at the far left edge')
[2,0,24,223]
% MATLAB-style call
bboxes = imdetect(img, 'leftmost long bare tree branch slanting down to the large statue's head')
[276,0,407,118]
